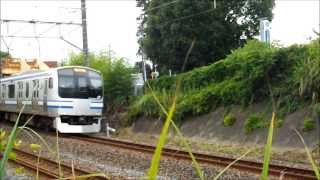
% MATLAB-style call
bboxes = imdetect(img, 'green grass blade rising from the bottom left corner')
[0,105,25,179]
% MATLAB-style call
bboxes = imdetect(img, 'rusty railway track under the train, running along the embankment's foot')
[66,135,316,179]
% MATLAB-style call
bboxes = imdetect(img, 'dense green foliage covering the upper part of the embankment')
[130,40,320,126]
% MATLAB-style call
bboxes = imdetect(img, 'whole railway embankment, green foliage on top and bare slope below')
[120,41,320,167]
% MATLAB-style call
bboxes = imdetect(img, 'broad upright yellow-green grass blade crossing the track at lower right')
[260,112,276,180]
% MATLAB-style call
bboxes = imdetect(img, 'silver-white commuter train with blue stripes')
[0,66,103,133]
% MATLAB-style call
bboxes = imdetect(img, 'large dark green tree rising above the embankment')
[137,0,274,72]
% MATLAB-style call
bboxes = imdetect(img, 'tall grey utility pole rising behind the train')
[81,0,89,66]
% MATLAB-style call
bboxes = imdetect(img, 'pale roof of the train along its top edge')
[0,66,101,82]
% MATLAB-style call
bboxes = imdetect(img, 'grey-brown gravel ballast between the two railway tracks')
[1,124,258,179]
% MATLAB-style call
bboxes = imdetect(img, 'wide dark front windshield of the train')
[58,68,102,99]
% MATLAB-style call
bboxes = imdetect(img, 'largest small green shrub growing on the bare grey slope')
[244,113,267,134]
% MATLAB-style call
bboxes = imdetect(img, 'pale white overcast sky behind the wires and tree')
[1,0,320,64]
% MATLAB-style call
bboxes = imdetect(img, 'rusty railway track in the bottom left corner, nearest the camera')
[1,149,107,180]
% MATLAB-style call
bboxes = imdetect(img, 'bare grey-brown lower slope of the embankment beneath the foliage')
[130,104,320,149]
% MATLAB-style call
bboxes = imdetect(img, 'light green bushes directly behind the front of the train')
[65,52,133,110]
